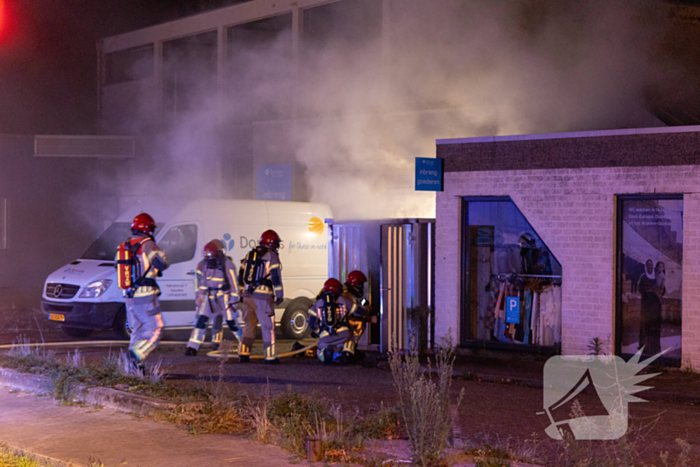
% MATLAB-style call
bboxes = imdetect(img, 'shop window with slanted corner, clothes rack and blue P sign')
[461,198,561,346]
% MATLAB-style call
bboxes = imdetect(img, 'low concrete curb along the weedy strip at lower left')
[0,367,177,415]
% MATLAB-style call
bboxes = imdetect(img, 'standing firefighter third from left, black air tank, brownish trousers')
[238,230,284,364]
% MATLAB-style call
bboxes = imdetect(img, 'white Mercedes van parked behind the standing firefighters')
[42,200,332,339]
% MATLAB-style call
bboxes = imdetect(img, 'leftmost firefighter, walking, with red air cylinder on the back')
[116,213,168,370]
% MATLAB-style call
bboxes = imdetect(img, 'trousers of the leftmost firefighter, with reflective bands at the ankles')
[126,295,163,363]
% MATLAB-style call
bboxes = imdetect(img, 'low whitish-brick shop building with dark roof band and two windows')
[435,127,700,368]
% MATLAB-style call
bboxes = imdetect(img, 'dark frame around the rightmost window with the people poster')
[613,193,685,367]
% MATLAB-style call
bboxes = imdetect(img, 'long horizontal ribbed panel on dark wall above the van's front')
[34,135,136,159]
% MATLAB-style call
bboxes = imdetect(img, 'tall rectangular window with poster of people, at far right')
[615,195,683,363]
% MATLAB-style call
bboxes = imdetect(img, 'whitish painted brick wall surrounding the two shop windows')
[435,165,700,368]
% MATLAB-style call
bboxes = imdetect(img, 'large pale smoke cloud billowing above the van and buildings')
[104,0,675,223]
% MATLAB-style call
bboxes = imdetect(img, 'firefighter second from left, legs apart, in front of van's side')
[185,240,241,356]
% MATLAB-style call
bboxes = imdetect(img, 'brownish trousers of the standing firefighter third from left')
[238,295,277,360]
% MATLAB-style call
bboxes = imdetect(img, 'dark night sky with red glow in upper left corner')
[0,0,241,134]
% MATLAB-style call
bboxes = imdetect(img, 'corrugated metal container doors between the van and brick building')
[328,219,435,352]
